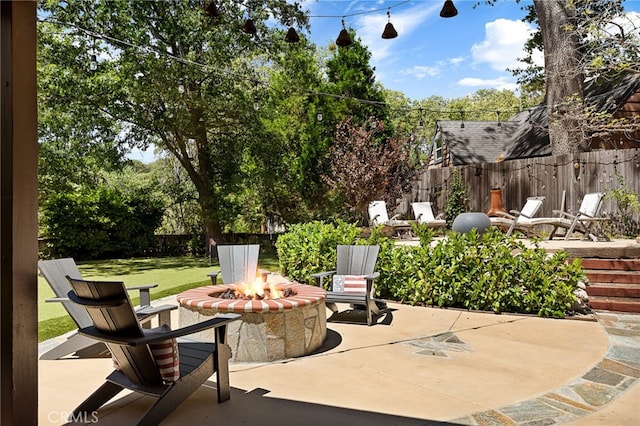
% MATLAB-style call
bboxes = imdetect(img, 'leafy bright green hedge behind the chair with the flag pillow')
[276,222,585,318]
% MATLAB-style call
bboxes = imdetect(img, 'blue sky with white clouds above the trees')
[302,0,640,100]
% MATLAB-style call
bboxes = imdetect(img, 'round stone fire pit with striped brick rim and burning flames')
[178,276,327,362]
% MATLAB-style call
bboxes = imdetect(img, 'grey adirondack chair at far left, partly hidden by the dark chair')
[38,258,178,360]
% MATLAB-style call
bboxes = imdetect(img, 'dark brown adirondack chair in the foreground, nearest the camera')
[67,277,240,426]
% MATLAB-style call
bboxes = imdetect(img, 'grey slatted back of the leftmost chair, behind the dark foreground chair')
[38,258,93,328]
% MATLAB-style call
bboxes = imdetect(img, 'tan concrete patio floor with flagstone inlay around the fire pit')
[39,300,640,426]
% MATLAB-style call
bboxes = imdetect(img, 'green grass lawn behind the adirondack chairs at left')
[38,253,279,342]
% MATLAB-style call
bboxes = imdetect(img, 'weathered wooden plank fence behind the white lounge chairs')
[397,148,640,219]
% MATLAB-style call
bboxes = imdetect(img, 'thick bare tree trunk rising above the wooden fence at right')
[533,0,588,155]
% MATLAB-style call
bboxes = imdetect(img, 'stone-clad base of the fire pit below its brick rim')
[179,284,327,362]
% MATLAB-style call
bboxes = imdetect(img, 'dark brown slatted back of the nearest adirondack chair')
[67,276,163,386]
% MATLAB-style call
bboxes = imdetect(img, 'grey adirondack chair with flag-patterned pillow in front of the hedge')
[311,245,386,326]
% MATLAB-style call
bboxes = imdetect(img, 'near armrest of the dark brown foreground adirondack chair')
[78,313,240,346]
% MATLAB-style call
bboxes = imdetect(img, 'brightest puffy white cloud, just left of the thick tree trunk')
[471,19,543,71]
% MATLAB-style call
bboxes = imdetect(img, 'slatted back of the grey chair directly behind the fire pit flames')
[218,244,260,284]
